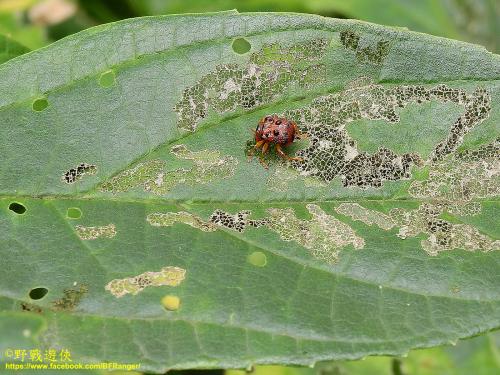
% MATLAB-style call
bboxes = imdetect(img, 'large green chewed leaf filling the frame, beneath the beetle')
[0,12,500,372]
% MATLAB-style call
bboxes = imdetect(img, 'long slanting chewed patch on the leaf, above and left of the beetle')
[174,38,329,131]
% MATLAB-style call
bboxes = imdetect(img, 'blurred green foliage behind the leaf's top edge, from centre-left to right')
[123,0,500,52]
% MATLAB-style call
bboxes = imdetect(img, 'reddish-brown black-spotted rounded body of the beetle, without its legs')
[255,115,297,146]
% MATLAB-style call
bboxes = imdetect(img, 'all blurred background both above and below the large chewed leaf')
[0,0,500,375]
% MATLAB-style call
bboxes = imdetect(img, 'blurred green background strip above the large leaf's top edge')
[0,0,500,53]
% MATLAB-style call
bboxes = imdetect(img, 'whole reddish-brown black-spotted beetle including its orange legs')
[249,115,304,168]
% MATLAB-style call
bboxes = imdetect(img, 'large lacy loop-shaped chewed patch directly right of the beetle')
[285,80,491,188]
